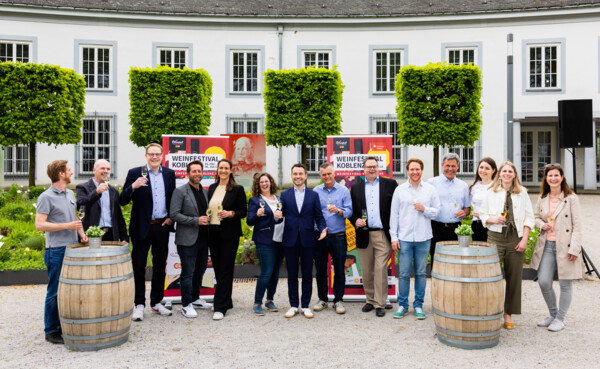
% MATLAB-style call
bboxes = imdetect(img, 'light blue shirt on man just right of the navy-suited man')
[314,182,352,233]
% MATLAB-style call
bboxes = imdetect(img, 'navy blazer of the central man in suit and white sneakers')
[281,187,327,247]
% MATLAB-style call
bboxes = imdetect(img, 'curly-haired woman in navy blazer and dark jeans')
[246,173,284,315]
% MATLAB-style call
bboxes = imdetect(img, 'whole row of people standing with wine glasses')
[35,143,583,343]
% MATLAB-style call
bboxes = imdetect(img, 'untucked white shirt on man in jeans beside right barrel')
[390,181,440,242]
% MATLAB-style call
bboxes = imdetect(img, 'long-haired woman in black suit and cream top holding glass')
[208,159,247,320]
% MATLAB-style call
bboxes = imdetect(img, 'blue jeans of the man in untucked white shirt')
[398,240,431,309]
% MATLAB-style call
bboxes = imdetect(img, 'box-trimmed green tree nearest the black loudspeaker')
[396,63,482,176]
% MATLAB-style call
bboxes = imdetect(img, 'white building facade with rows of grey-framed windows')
[0,0,600,190]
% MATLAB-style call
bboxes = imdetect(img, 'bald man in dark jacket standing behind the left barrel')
[75,159,129,242]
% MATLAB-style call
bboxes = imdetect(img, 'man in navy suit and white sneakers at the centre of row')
[281,164,327,318]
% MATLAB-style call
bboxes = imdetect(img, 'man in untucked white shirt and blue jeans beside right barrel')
[390,159,440,319]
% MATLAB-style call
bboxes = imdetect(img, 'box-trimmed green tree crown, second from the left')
[129,66,212,146]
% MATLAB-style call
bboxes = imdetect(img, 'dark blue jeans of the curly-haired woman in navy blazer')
[254,242,283,305]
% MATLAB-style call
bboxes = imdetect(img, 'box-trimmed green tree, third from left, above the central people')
[264,68,344,163]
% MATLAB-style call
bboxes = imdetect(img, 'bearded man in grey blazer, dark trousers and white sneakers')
[170,160,212,318]
